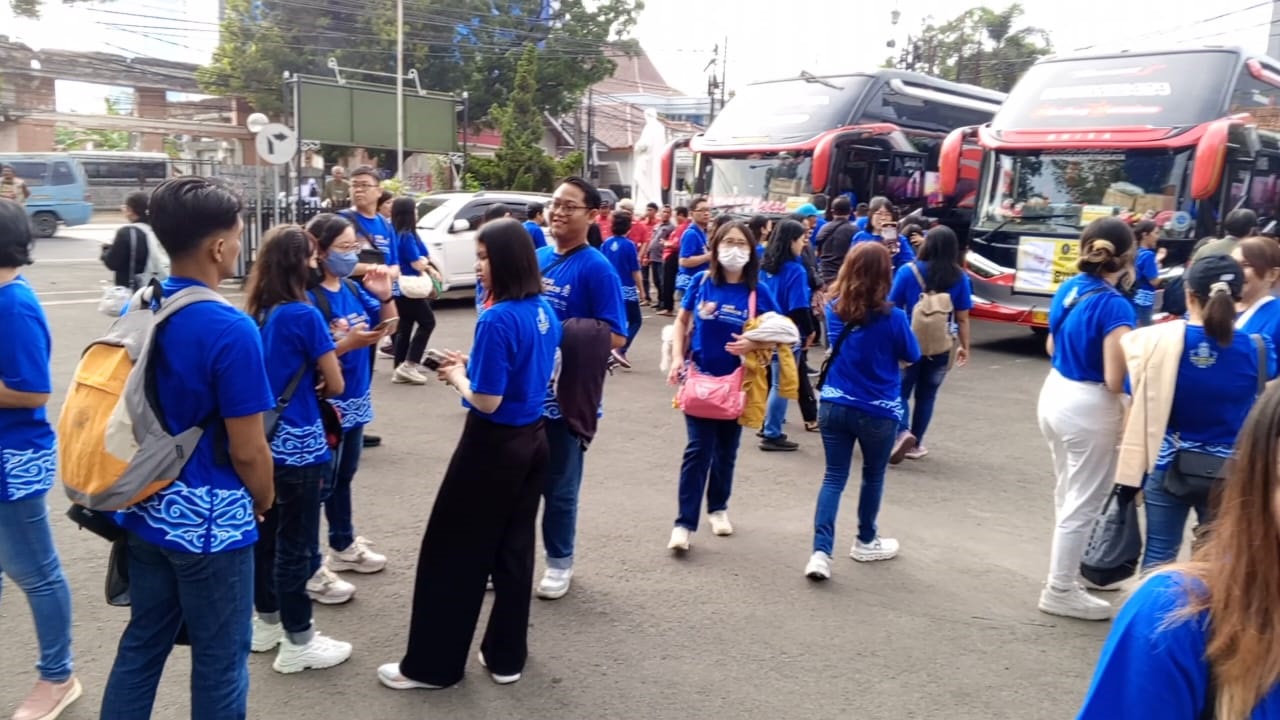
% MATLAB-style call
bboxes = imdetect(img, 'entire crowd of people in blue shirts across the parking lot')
[10,168,1280,720]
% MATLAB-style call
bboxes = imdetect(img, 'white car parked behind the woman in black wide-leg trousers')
[417,191,552,292]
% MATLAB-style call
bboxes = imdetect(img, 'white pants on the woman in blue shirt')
[1036,370,1124,589]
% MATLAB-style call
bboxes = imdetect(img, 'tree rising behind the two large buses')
[884,3,1053,92]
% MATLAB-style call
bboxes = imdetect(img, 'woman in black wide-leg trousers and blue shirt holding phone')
[378,219,561,691]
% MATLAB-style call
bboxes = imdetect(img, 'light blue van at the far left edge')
[0,152,93,237]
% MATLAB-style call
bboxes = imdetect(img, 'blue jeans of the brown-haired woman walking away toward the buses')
[813,402,897,555]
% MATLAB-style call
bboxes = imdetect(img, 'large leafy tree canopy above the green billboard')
[198,0,644,120]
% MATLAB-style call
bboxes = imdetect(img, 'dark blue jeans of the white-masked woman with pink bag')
[676,415,742,532]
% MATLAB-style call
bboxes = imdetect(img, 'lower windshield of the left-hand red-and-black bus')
[703,152,813,214]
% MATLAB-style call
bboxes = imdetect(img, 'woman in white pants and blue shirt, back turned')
[1037,218,1137,620]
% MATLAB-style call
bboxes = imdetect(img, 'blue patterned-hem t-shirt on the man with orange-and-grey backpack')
[118,277,275,553]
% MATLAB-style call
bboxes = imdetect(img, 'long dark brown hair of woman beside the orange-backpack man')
[244,224,315,316]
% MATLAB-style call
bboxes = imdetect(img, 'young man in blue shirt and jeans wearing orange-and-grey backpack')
[96,177,275,720]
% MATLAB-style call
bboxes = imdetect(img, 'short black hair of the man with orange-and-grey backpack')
[150,176,243,259]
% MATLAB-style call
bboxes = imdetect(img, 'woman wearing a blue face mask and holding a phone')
[307,214,397,605]
